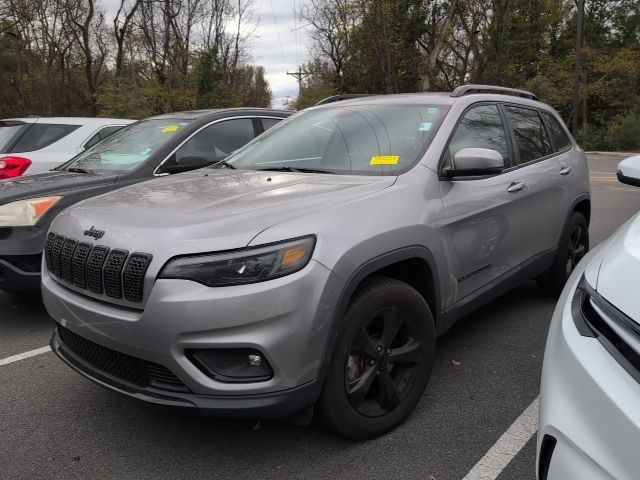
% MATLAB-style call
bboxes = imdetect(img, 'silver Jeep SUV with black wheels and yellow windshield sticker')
[42,85,590,438]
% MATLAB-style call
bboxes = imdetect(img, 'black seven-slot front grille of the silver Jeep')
[44,232,151,302]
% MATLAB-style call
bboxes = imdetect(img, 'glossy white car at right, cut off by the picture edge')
[537,156,640,480]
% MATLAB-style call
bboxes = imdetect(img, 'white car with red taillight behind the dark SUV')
[0,117,134,179]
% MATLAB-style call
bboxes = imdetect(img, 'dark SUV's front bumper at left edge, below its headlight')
[0,226,46,293]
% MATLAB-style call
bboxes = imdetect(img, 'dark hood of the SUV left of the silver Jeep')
[0,171,117,205]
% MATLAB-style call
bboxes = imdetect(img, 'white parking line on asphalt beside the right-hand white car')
[462,397,540,480]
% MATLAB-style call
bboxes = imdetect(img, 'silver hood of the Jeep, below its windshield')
[51,169,396,258]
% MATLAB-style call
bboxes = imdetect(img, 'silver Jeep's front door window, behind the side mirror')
[444,105,510,168]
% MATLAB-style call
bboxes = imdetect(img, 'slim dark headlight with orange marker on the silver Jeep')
[160,237,316,287]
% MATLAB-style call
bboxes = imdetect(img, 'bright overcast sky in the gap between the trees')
[252,0,308,107]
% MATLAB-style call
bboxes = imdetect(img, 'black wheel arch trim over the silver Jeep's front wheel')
[318,245,442,382]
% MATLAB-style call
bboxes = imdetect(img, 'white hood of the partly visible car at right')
[596,213,640,323]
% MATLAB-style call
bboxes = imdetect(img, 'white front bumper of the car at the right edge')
[538,276,640,480]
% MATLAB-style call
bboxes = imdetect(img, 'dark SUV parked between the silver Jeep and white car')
[0,108,291,293]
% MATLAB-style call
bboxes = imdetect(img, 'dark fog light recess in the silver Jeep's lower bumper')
[186,348,273,383]
